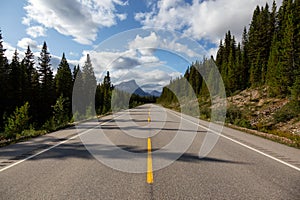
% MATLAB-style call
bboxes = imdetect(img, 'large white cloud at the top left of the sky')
[23,0,127,44]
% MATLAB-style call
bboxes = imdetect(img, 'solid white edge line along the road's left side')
[0,114,125,172]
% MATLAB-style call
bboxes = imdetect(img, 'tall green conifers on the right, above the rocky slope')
[159,0,300,103]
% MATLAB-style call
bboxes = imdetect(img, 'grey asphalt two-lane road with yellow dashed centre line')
[0,104,300,199]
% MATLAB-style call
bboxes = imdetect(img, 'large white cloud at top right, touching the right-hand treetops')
[135,0,282,44]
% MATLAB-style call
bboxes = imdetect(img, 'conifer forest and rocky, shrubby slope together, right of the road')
[158,0,300,148]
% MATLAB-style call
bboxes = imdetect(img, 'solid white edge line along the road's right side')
[169,111,300,171]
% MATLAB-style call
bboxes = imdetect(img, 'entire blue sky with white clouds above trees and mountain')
[0,0,282,92]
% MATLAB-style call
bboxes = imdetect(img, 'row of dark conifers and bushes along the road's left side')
[0,32,113,138]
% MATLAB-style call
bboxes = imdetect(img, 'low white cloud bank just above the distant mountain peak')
[80,31,193,91]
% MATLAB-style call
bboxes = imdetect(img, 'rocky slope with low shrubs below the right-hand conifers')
[219,87,300,148]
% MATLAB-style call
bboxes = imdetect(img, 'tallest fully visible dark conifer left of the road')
[38,42,56,123]
